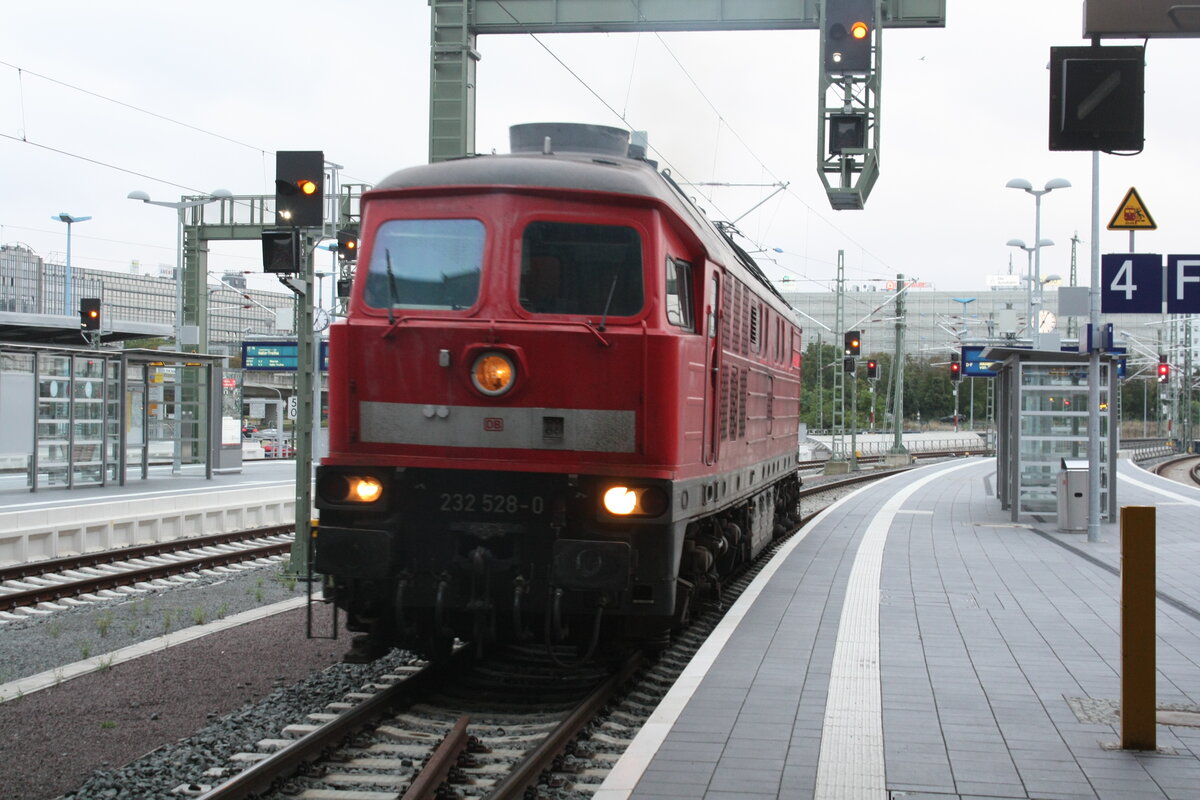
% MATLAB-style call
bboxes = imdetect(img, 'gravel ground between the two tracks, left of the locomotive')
[0,566,412,800]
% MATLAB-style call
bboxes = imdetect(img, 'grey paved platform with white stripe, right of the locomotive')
[594,458,1200,800]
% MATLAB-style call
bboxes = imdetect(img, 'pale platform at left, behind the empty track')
[0,459,296,566]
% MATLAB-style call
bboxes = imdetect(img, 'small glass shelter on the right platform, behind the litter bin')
[984,348,1118,522]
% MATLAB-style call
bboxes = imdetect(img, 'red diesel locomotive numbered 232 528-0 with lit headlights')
[314,125,800,660]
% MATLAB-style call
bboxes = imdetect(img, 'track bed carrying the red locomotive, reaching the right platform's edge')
[171,468,910,800]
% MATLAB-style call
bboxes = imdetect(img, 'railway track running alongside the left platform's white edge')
[0,525,294,612]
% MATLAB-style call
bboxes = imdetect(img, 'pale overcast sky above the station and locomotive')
[0,0,1200,298]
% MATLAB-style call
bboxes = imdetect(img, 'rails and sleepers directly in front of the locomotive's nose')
[194,648,641,800]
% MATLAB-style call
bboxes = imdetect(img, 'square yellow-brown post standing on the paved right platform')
[1121,506,1157,750]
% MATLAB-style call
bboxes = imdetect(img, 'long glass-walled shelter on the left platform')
[0,344,234,492]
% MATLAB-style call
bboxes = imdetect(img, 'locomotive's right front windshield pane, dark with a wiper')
[520,222,644,317]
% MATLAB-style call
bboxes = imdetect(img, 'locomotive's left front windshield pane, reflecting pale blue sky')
[365,219,484,311]
